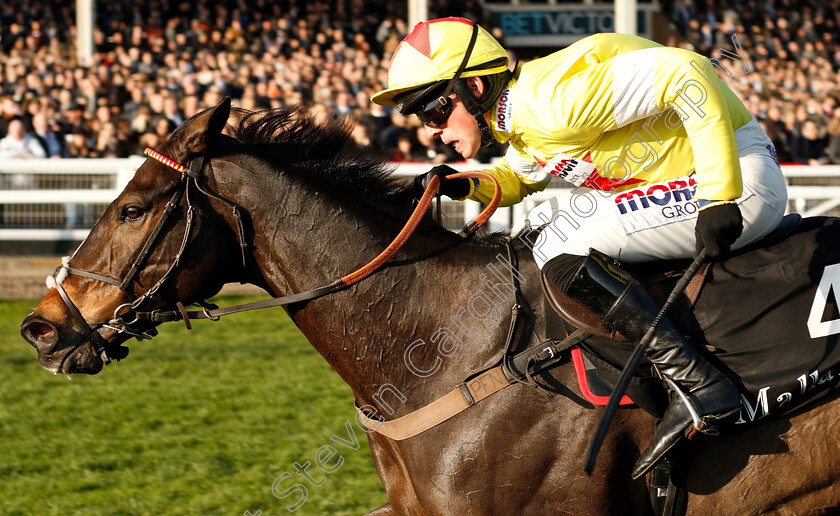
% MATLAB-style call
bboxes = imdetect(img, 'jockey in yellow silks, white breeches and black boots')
[371,18,787,478]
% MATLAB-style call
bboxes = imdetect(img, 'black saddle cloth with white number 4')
[547,217,840,425]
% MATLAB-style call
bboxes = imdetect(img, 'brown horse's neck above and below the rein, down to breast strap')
[236,171,535,411]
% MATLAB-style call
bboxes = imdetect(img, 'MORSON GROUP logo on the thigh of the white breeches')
[614,176,699,235]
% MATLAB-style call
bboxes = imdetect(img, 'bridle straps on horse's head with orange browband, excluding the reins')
[47,148,247,364]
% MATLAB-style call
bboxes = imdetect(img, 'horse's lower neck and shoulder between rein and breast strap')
[293,239,544,414]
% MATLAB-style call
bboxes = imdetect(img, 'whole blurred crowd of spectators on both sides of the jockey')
[0,0,840,163]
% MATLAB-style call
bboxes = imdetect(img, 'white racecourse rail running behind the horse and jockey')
[0,156,840,241]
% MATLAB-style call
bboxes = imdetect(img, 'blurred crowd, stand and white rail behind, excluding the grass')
[0,0,840,274]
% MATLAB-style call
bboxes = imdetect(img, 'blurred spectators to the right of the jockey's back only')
[670,0,840,165]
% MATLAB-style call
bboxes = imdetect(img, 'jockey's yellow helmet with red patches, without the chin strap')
[371,18,508,113]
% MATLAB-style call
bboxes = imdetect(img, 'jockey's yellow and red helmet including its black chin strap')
[371,18,511,145]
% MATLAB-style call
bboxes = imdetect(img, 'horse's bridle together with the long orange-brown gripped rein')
[47,148,501,364]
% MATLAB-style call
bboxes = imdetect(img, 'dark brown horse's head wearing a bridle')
[21,99,242,374]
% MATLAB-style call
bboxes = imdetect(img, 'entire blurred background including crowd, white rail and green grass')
[0,0,840,514]
